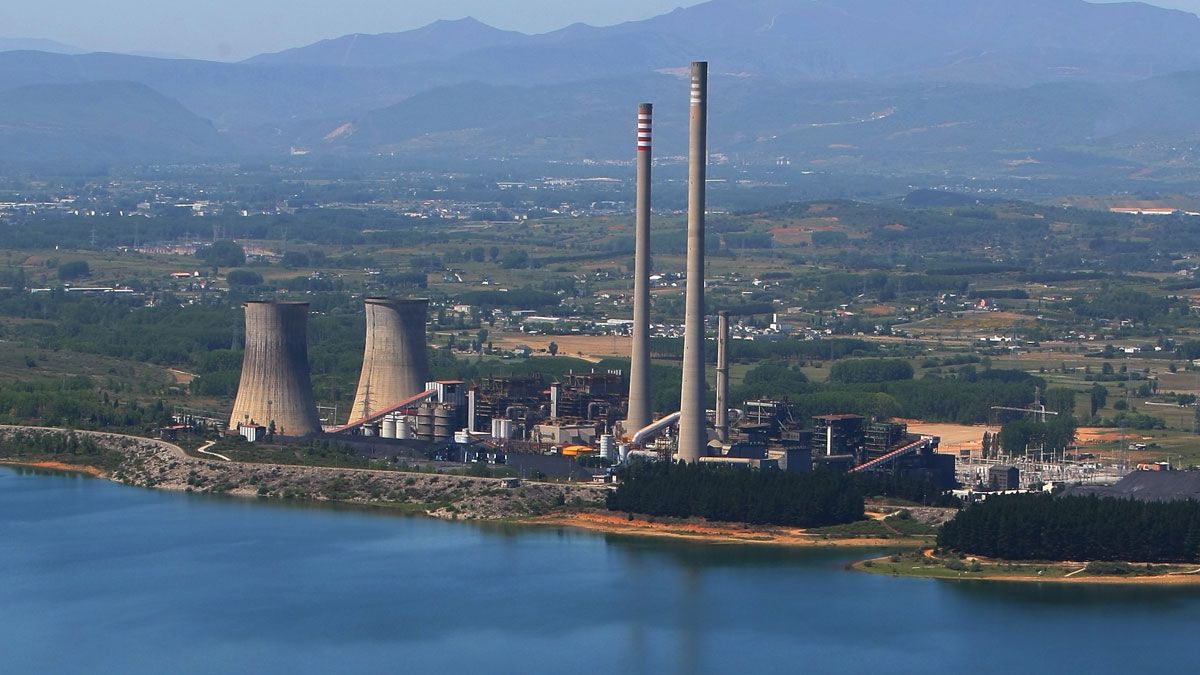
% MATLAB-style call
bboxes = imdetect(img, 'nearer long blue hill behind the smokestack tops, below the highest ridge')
[312,72,1200,178]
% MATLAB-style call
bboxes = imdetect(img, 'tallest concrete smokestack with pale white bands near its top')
[678,61,708,462]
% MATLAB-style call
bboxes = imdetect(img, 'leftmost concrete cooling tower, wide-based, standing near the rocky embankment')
[229,303,320,436]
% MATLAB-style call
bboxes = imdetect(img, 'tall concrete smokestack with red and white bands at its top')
[625,103,654,436]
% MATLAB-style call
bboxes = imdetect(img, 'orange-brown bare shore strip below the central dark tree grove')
[525,510,929,549]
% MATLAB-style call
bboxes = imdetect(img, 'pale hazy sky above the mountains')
[0,0,1200,59]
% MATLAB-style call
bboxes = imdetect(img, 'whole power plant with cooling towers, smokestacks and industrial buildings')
[208,61,953,482]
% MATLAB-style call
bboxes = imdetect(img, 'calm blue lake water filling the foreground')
[0,468,1200,675]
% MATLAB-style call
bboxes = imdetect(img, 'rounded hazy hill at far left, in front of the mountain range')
[0,82,232,167]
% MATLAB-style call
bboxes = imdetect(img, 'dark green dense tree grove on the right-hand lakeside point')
[937,494,1200,562]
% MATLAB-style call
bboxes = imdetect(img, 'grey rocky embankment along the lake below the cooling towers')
[0,426,606,520]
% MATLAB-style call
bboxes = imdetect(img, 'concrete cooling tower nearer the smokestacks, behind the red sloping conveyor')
[349,298,430,423]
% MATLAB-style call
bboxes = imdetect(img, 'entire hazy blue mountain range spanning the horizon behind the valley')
[7,0,1200,177]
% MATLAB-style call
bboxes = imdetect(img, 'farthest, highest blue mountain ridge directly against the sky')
[241,0,1200,84]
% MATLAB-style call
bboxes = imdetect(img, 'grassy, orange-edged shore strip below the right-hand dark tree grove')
[847,550,1200,586]
